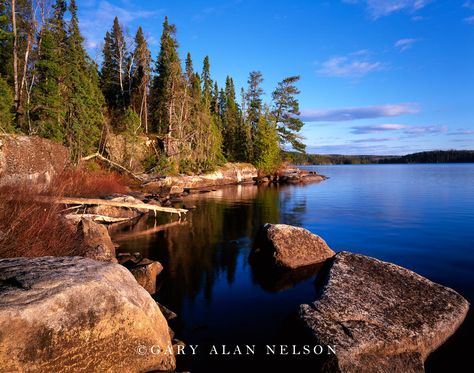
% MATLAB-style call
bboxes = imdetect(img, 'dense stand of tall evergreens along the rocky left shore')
[0,0,305,172]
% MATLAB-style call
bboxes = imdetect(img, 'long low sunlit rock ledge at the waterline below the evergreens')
[144,163,257,193]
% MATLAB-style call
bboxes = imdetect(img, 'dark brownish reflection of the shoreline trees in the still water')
[112,185,298,312]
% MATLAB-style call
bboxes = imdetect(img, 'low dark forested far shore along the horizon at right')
[284,150,474,165]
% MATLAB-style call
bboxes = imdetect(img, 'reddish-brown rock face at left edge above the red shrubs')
[0,135,69,187]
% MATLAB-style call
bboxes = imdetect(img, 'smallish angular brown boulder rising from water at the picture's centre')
[250,224,334,269]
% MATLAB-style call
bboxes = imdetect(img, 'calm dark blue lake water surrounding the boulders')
[116,164,474,373]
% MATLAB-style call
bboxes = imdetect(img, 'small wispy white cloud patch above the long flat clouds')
[318,50,386,78]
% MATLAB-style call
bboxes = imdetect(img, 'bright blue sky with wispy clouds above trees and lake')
[78,0,474,154]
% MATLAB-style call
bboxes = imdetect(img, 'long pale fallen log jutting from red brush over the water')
[35,196,188,217]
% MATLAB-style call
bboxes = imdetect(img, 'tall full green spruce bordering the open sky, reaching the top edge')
[66,0,104,160]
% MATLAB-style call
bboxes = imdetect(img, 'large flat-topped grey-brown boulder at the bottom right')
[299,252,469,373]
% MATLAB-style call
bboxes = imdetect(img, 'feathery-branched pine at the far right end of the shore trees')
[271,76,306,152]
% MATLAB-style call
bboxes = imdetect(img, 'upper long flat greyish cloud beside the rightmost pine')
[301,103,420,122]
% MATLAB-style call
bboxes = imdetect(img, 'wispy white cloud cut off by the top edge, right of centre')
[343,0,432,19]
